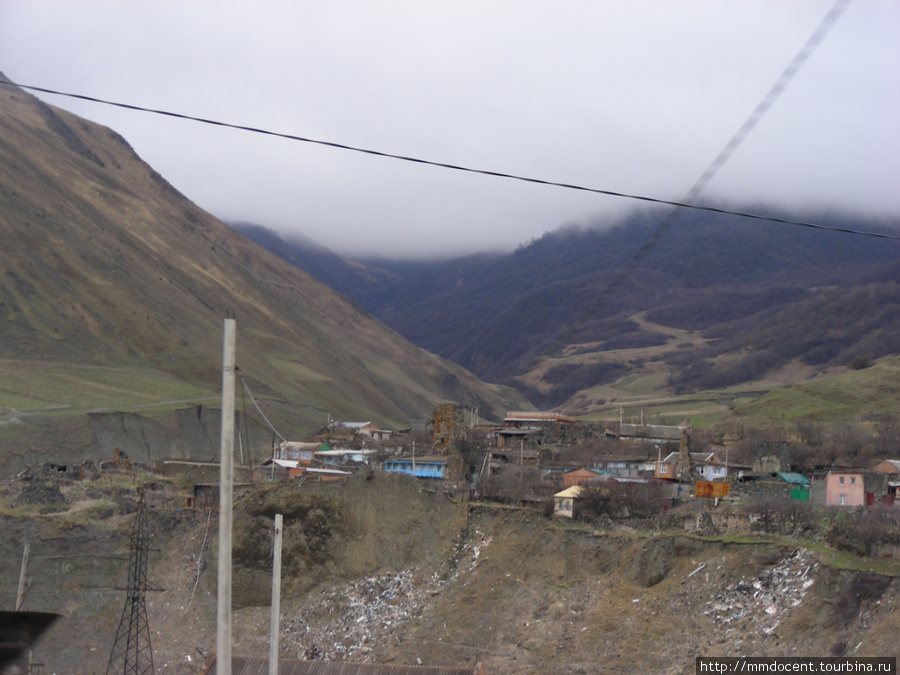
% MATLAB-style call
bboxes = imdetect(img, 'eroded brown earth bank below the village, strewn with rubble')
[0,472,900,675]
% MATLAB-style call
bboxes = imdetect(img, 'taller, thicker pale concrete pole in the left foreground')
[216,319,236,675]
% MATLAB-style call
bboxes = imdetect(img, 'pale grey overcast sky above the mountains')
[0,0,900,256]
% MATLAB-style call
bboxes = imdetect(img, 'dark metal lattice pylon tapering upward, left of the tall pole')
[106,489,155,675]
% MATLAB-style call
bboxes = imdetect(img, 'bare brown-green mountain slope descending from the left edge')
[0,75,524,470]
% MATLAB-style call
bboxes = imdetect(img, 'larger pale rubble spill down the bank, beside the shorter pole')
[281,532,491,661]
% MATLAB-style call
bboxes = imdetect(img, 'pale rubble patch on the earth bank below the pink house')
[704,551,817,635]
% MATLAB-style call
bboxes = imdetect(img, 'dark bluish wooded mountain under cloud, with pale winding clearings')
[237,209,900,411]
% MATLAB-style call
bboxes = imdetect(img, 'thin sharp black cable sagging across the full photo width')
[0,41,900,240]
